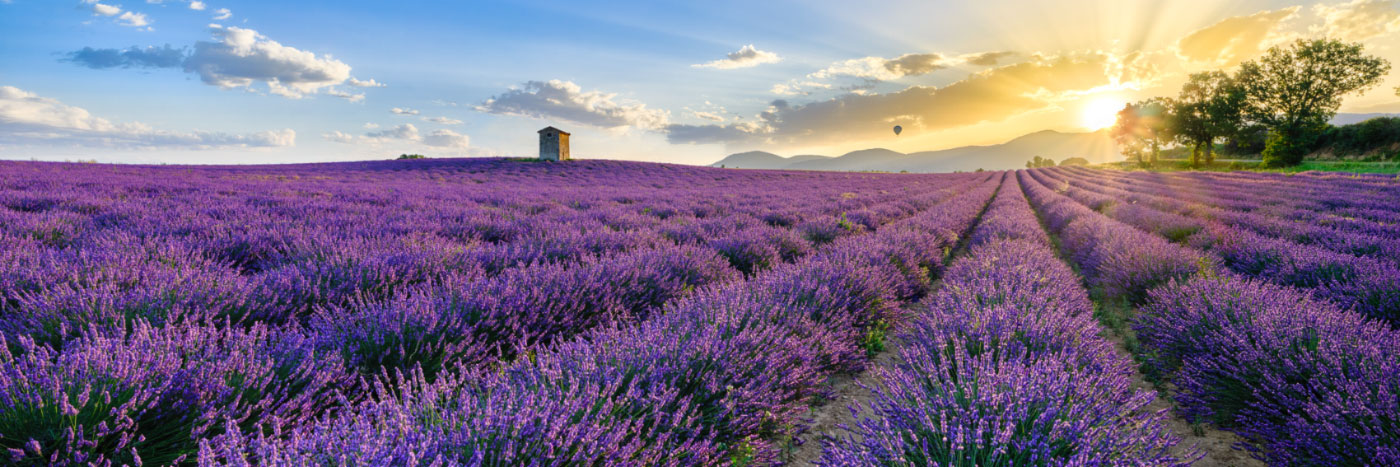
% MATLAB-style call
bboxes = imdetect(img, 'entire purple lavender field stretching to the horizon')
[0,159,1400,466]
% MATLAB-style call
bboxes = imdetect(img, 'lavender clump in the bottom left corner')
[0,323,349,466]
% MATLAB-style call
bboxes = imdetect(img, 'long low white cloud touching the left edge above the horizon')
[0,85,297,150]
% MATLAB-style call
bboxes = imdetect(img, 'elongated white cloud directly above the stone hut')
[476,80,669,129]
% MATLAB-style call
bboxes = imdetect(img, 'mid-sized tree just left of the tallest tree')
[1169,71,1245,165]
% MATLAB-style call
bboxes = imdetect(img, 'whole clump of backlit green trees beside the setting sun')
[1110,39,1400,166]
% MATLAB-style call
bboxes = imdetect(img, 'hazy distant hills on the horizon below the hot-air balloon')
[713,130,1121,172]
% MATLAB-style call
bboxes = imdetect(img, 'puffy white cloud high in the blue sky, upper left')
[183,25,350,98]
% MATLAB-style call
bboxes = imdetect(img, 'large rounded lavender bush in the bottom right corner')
[1137,277,1400,466]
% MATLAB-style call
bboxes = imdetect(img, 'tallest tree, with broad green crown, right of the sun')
[1236,39,1390,166]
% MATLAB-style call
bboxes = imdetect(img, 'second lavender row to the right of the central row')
[1033,165,1400,323]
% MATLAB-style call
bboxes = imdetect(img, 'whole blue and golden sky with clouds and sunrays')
[0,0,1400,164]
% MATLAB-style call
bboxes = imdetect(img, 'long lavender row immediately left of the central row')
[199,170,1000,466]
